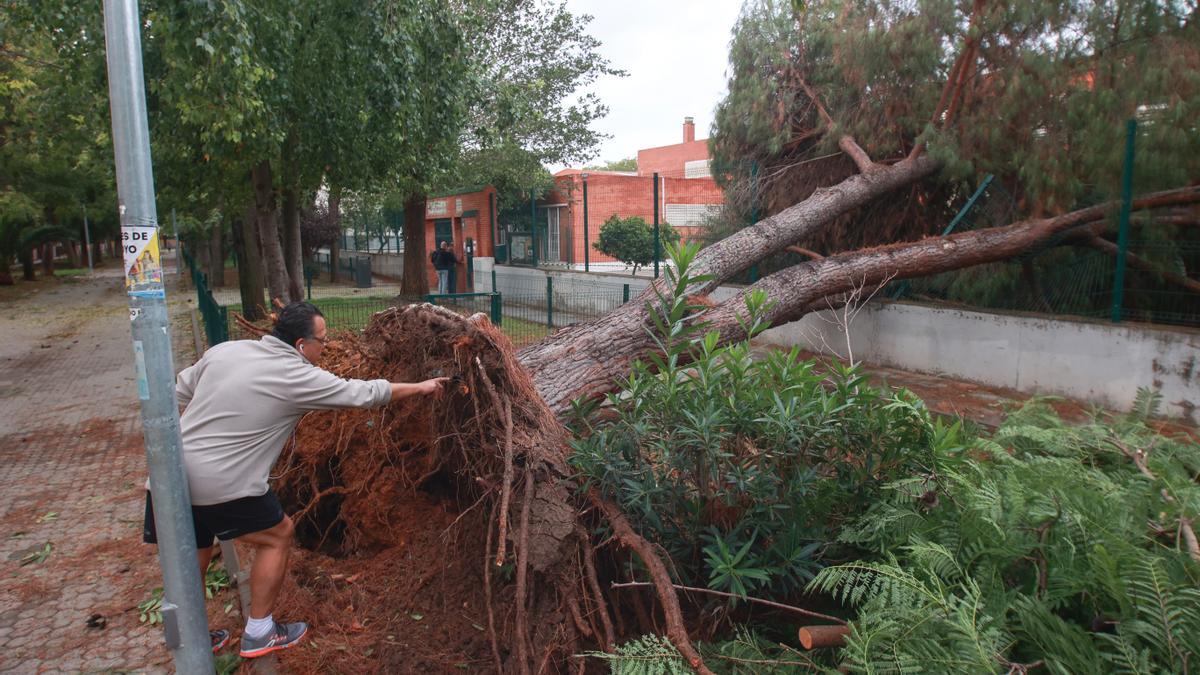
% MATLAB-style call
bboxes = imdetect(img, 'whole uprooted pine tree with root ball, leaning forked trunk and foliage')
[265,1,1200,673]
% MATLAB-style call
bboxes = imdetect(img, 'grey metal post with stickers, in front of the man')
[104,0,212,674]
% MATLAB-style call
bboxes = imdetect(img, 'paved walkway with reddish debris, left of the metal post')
[0,267,194,673]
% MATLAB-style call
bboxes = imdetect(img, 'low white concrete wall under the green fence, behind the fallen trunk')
[762,303,1200,423]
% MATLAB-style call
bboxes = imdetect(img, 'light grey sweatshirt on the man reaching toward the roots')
[166,335,391,506]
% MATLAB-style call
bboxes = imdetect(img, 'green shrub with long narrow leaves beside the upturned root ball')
[571,240,940,596]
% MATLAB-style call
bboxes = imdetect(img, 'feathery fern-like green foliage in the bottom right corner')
[810,394,1200,674]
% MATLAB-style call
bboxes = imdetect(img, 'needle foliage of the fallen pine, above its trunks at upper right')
[707,0,1200,314]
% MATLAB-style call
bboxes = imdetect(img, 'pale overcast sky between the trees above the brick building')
[566,0,742,163]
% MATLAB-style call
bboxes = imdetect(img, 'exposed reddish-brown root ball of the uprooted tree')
[277,305,708,674]
